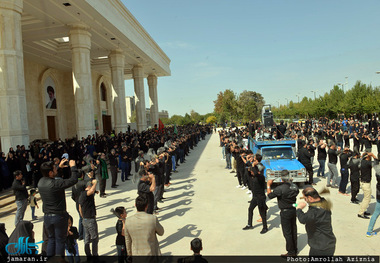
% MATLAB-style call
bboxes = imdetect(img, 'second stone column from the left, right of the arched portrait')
[69,23,95,139]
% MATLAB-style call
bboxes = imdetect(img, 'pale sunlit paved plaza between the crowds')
[0,134,380,256]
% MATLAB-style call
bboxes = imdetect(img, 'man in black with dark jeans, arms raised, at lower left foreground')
[38,159,78,257]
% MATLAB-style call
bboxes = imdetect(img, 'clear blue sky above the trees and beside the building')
[122,0,380,116]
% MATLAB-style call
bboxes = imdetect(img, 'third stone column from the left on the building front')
[108,49,127,133]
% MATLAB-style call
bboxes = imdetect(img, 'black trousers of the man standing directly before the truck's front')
[280,208,298,254]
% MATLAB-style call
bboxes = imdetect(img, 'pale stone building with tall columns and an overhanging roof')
[0,0,170,152]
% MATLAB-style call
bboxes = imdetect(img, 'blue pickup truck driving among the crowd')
[249,138,307,184]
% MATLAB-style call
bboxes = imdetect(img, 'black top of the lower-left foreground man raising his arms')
[38,166,78,214]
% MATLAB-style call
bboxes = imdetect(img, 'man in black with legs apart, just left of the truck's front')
[243,154,268,234]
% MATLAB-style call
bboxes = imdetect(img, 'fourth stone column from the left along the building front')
[132,65,146,132]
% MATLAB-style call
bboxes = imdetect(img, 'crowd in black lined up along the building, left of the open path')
[0,125,212,262]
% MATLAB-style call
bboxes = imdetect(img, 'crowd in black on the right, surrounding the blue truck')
[219,117,380,256]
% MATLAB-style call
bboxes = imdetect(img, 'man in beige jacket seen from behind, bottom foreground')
[125,195,164,256]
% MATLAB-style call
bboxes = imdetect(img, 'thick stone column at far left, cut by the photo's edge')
[0,0,29,153]
